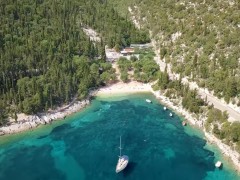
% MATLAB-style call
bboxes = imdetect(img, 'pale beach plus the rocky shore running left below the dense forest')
[0,81,151,136]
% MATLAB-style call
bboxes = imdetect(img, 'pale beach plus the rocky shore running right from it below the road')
[96,81,240,172]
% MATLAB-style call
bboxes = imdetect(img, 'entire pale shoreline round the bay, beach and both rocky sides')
[0,81,240,172]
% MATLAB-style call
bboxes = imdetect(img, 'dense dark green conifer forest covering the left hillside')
[0,0,149,125]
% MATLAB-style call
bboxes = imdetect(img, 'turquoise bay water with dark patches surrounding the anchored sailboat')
[0,94,240,180]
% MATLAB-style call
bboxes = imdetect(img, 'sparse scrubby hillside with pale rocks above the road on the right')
[110,0,240,105]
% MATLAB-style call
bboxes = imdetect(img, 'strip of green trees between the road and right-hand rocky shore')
[153,69,240,153]
